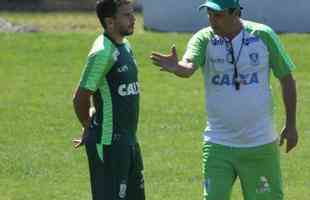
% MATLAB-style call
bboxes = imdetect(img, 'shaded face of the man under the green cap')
[208,8,235,36]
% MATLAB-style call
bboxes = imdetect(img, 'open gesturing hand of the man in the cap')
[150,45,178,73]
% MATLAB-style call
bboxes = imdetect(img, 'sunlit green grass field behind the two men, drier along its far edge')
[0,12,310,200]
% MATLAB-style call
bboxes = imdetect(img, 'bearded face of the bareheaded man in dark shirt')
[114,3,136,36]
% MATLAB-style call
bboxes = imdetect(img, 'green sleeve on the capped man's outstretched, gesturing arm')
[183,27,214,67]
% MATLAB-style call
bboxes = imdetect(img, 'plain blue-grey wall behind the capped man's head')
[142,0,310,32]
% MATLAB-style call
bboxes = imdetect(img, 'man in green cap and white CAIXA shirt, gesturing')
[151,0,298,200]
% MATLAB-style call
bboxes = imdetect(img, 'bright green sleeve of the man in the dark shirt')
[80,34,118,91]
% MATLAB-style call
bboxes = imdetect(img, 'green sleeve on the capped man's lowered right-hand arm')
[243,21,296,79]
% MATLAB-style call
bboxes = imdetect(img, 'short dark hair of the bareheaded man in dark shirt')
[96,0,130,28]
